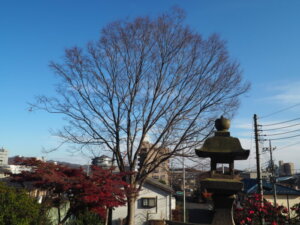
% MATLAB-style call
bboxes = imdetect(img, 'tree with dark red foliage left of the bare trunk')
[11,158,126,224]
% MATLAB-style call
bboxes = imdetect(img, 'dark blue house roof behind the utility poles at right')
[242,179,300,196]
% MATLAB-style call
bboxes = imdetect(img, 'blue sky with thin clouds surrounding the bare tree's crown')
[0,0,300,169]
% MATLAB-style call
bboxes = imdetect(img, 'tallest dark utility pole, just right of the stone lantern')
[253,114,264,225]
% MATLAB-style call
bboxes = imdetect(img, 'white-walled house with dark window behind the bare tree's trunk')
[112,178,175,225]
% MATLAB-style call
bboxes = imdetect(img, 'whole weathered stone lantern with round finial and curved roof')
[196,116,250,225]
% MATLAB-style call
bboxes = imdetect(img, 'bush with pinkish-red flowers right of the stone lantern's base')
[234,194,288,225]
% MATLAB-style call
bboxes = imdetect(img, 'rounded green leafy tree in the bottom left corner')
[0,182,47,225]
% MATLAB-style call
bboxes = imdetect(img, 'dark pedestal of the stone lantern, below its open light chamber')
[201,178,243,225]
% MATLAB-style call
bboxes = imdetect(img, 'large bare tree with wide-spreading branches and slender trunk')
[35,10,249,225]
